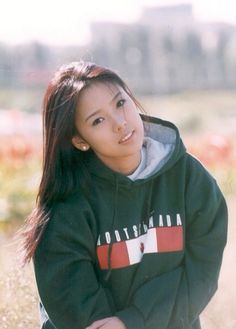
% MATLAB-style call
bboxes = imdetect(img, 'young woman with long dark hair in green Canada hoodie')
[21,62,227,329]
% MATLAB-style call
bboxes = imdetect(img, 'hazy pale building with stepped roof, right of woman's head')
[91,4,236,93]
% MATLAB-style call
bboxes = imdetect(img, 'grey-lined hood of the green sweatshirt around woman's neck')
[86,114,186,185]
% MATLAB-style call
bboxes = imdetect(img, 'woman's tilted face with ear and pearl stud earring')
[72,82,144,174]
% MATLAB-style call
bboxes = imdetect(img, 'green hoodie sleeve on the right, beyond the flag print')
[117,157,227,329]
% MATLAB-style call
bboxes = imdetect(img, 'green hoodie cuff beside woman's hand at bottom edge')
[115,307,145,329]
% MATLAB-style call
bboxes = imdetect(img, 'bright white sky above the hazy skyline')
[0,0,236,45]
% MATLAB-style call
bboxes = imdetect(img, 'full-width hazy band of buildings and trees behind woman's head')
[0,4,236,94]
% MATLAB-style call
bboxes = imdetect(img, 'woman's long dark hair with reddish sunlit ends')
[21,61,142,264]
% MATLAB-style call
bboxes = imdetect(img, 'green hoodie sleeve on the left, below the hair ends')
[34,197,113,329]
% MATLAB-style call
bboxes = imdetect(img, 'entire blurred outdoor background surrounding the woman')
[0,0,236,329]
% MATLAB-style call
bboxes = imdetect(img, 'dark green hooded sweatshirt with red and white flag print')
[34,116,227,329]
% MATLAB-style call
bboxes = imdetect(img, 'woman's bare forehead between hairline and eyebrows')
[77,82,125,112]
